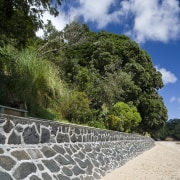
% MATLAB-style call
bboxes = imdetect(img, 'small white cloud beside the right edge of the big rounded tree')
[156,67,177,85]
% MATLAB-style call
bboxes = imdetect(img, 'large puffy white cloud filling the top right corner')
[121,0,180,43]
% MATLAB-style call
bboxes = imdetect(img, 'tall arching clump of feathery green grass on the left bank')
[0,46,64,118]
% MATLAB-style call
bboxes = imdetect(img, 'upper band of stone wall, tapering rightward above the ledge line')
[0,114,150,144]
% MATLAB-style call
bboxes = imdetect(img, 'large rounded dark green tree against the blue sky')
[58,29,167,133]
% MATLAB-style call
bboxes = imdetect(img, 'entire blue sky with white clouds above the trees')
[39,0,180,119]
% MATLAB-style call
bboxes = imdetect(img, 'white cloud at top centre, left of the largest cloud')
[70,0,122,29]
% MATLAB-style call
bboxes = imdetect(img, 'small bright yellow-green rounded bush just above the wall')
[105,102,141,132]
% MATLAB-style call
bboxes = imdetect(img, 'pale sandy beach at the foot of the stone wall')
[101,141,180,180]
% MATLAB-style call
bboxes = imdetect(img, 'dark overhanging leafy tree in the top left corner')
[0,0,62,48]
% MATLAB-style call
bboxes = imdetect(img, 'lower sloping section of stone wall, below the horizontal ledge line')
[0,139,154,180]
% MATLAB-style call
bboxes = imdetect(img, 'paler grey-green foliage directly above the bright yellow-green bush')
[89,69,140,107]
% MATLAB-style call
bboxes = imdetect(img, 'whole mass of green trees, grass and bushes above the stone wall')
[0,0,167,134]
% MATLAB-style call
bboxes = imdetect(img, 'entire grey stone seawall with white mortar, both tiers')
[0,114,154,180]
